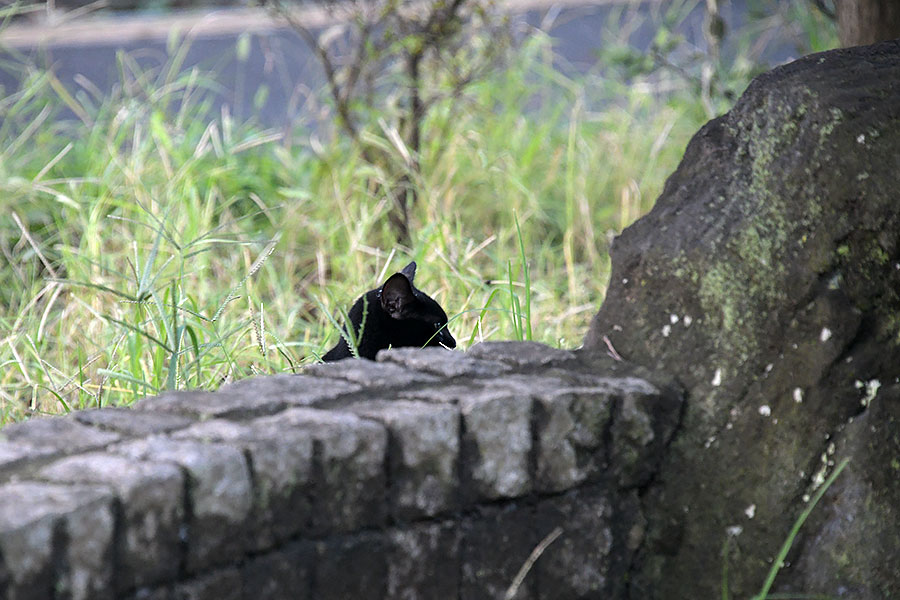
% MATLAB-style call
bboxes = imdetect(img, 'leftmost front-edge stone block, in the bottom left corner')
[0,482,115,600]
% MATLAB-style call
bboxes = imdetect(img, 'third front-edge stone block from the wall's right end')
[459,391,532,500]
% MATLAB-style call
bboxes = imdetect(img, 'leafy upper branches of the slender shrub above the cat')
[270,0,510,244]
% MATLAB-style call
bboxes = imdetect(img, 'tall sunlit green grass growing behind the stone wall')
[0,1,836,423]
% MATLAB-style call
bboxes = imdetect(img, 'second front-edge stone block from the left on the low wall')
[39,452,185,592]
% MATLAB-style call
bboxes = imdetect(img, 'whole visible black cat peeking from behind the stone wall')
[322,262,456,362]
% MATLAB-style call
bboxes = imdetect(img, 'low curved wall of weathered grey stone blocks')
[0,342,681,600]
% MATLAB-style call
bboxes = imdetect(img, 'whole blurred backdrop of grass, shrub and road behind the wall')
[0,0,885,422]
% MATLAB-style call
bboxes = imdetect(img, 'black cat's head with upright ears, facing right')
[379,262,456,348]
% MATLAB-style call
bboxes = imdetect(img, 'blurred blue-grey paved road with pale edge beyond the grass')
[0,0,791,127]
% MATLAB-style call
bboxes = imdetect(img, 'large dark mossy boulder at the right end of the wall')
[582,41,900,600]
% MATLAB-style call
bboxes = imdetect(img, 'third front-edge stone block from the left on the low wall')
[111,437,253,573]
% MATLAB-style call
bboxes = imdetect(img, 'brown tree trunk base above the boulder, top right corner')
[835,0,900,47]
